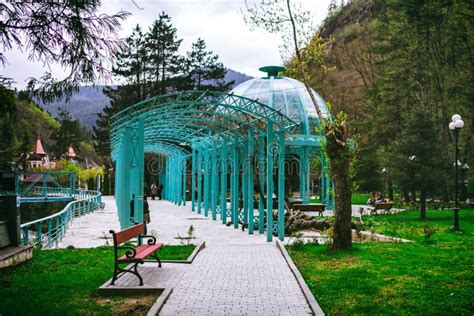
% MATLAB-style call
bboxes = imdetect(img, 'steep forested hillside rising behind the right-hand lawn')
[311,0,474,205]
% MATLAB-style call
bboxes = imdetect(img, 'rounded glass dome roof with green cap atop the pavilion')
[232,66,330,134]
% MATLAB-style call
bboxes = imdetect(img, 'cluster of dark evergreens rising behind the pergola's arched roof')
[93,12,233,166]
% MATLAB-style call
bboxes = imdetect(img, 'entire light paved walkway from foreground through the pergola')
[60,197,311,316]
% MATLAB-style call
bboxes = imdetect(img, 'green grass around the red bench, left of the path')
[0,245,195,316]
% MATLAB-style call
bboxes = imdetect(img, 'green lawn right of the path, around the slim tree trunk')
[288,210,474,315]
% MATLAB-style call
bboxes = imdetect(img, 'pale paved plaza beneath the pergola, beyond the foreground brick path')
[59,196,272,248]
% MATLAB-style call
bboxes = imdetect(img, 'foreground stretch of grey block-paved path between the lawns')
[161,244,311,316]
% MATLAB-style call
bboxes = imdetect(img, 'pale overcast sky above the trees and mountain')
[0,0,330,88]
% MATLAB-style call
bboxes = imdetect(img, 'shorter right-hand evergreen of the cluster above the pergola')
[185,38,233,91]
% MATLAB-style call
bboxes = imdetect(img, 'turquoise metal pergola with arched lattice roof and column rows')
[111,69,336,241]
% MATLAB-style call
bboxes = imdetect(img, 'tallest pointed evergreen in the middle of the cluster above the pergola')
[146,12,182,95]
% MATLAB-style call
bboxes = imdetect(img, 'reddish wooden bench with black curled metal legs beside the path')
[109,224,163,285]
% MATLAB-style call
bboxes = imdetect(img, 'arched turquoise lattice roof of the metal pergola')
[111,91,298,156]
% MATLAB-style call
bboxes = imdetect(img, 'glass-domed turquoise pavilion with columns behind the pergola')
[231,66,334,209]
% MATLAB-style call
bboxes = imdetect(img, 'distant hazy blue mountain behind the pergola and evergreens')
[39,68,253,129]
